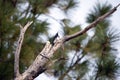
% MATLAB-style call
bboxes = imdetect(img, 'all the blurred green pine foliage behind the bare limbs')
[0,0,120,80]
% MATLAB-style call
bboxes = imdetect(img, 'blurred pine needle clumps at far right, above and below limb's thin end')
[85,1,120,80]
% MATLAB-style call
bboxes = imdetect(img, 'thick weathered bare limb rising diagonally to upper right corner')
[16,4,120,80]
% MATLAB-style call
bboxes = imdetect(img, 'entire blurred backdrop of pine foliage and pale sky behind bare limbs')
[0,0,120,80]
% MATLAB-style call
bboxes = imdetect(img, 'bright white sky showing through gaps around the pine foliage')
[35,0,120,80]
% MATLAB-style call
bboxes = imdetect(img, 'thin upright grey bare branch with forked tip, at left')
[14,21,32,77]
